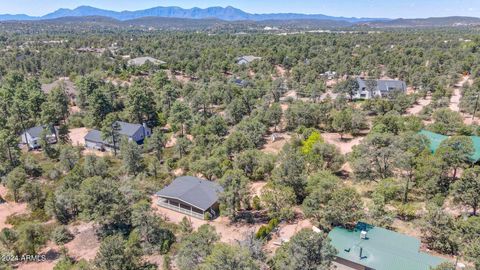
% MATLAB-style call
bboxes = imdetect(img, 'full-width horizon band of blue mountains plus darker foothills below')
[0,6,480,29]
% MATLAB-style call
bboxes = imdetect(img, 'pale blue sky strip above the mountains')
[0,0,480,18]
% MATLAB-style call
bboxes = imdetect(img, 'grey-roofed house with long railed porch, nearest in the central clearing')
[155,176,223,219]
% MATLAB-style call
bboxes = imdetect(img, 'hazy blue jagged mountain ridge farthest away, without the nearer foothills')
[0,6,389,23]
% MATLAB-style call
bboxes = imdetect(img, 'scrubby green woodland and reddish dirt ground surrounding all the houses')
[0,25,480,270]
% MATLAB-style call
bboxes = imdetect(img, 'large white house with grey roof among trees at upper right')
[353,78,407,99]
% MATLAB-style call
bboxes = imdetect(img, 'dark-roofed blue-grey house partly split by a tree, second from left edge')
[84,121,152,150]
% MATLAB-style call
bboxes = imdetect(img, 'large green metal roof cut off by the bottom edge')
[328,223,446,270]
